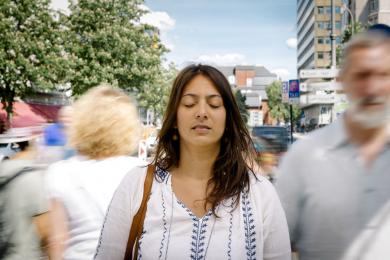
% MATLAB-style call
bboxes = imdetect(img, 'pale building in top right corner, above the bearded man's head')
[349,0,390,24]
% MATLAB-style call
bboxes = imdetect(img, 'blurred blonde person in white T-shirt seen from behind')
[47,86,144,260]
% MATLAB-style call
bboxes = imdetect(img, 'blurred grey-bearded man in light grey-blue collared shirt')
[276,27,390,260]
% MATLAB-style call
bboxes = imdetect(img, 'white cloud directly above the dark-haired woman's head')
[194,53,248,66]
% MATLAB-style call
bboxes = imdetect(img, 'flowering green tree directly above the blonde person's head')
[62,0,165,96]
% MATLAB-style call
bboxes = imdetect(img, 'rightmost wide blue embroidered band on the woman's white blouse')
[242,191,256,260]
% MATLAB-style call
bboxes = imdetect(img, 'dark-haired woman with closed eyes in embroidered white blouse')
[95,65,291,260]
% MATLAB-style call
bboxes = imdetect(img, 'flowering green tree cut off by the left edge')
[0,0,68,120]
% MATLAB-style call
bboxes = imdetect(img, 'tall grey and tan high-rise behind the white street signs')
[297,0,343,129]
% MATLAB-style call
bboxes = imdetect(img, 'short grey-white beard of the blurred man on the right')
[347,97,390,129]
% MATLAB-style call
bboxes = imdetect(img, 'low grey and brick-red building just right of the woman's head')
[219,66,278,127]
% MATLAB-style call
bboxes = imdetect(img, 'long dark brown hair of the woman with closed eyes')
[153,64,254,214]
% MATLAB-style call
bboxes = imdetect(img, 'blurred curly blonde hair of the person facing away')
[69,85,141,159]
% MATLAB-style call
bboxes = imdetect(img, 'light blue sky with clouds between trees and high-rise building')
[52,0,297,80]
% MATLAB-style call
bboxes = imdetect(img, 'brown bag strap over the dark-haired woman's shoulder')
[125,165,156,260]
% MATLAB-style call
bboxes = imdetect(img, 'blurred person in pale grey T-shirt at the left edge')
[0,135,54,260]
